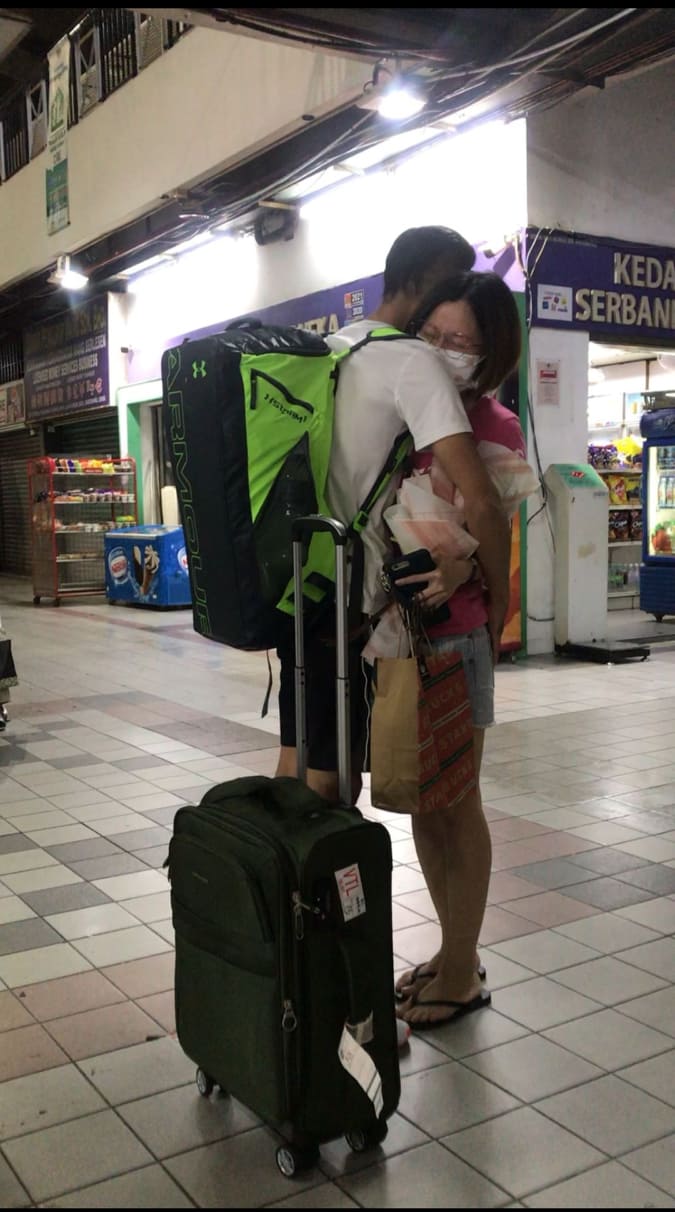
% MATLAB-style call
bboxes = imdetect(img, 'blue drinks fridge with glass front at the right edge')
[640,391,675,623]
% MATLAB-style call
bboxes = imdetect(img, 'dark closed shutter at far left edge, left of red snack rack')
[0,429,42,577]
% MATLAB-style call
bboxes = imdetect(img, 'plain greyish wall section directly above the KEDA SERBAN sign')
[527,59,675,245]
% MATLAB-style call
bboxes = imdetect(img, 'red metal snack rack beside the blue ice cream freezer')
[28,456,137,606]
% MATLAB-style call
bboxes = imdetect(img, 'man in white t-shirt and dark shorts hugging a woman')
[276,227,510,802]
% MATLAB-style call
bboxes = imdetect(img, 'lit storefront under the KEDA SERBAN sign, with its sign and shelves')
[527,228,675,651]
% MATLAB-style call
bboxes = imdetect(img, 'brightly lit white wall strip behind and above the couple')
[128,122,526,382]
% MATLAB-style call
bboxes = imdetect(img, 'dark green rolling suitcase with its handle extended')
[168,516,400,1177]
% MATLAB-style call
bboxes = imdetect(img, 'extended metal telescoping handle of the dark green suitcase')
[291,514,351,807]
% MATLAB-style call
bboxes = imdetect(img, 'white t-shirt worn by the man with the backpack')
[326,320,471,614]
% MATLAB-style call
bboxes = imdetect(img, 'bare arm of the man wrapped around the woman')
[431,434,511,663]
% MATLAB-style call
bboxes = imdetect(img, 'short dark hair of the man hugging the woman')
[383,227,476,299]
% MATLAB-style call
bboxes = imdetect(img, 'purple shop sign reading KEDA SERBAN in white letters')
[526,228,675,342]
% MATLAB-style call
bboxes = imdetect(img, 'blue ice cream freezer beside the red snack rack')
[105,525,191,606]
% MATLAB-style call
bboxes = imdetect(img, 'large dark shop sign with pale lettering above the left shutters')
[23,296,110,421]
